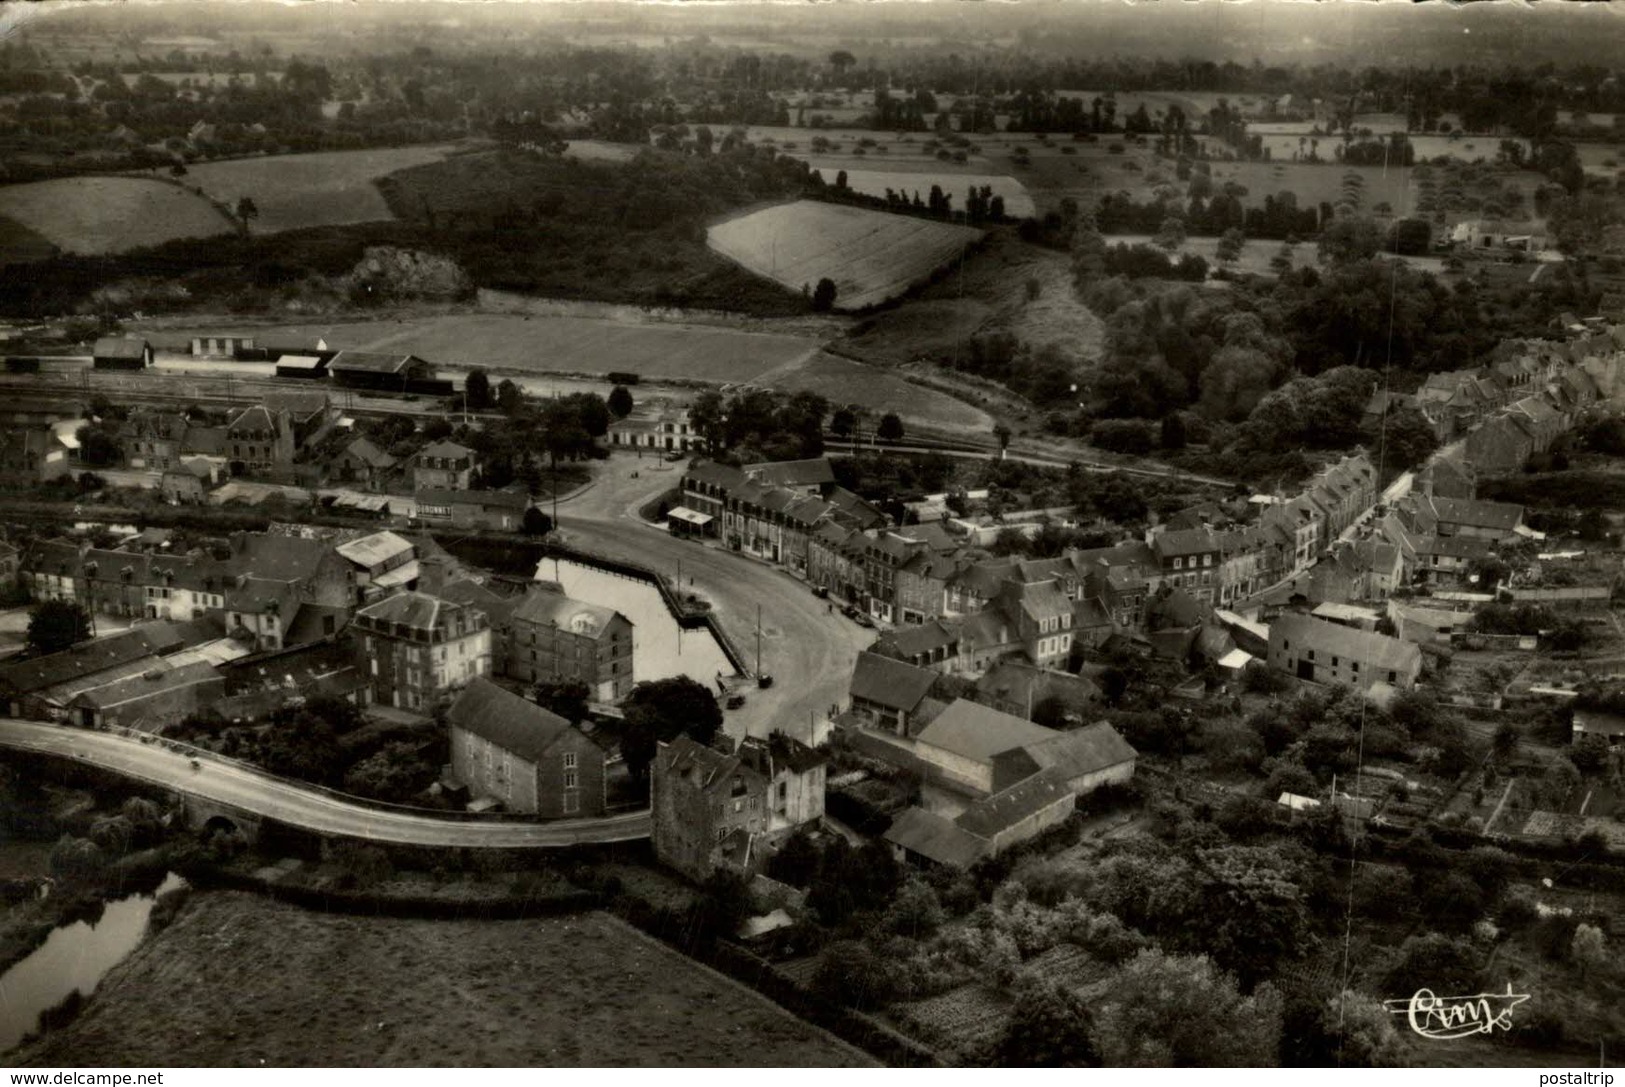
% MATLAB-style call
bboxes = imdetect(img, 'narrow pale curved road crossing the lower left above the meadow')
[0,720,648,848]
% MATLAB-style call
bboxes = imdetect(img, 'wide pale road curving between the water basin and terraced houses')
[559,452,874,741]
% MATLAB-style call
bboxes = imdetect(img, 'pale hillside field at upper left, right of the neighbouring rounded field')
[187,145,474,234]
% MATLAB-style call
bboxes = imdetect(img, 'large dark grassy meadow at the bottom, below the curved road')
[23,892,873,1068]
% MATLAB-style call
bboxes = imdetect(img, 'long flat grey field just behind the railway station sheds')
[126,314,817,382]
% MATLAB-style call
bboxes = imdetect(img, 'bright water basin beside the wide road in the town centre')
[536,559,735,687]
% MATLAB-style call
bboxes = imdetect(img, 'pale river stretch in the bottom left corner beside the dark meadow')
[0,873,185,1053]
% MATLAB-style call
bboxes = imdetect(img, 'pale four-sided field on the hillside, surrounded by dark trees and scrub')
[705,200,982,310]
